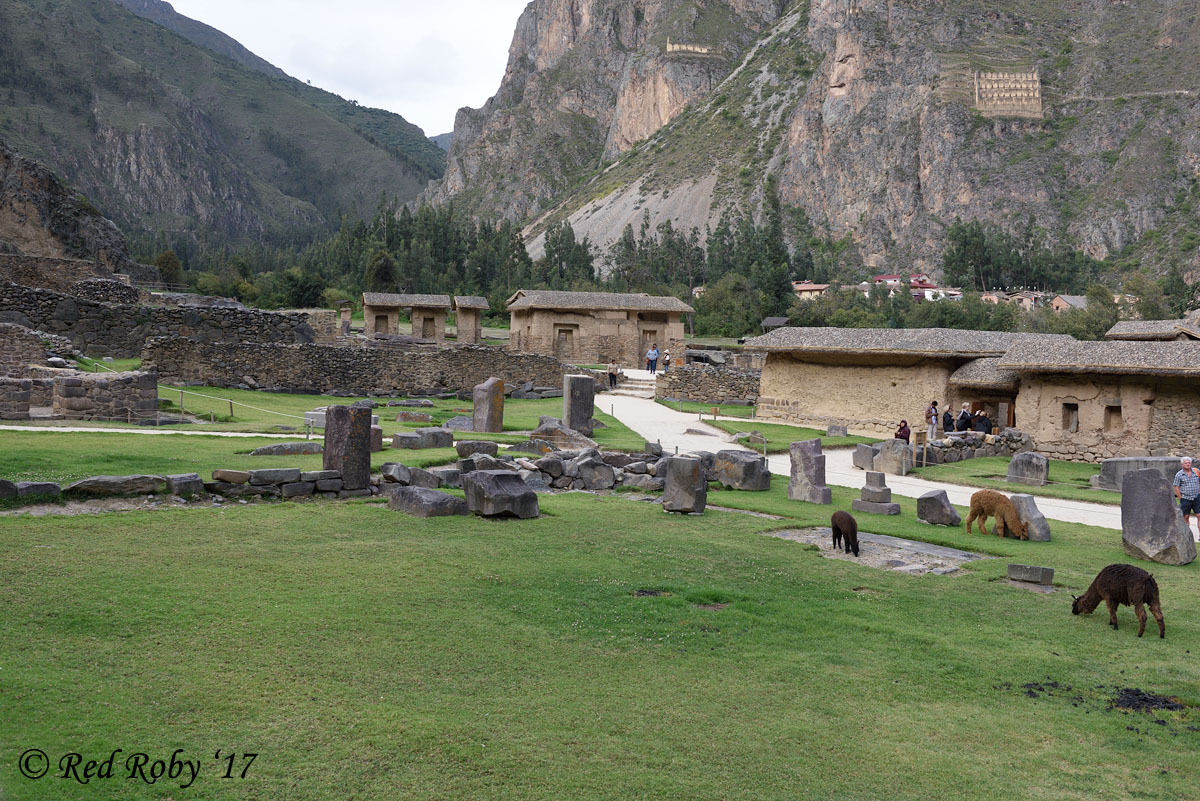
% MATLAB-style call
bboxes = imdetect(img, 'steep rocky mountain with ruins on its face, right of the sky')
[431,0,1200,277]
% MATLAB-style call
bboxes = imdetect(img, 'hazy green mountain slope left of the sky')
[0,0,443,253]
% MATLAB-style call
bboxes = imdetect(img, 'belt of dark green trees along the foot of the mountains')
[147,183,1194,339]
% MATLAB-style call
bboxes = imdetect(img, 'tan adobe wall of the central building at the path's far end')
[508,309,685,368]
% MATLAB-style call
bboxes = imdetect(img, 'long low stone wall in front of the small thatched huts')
[142,337,608,395]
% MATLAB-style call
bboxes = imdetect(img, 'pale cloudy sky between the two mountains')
[170,0,529,137]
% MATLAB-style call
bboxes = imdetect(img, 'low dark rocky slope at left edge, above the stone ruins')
[0,136,144,278]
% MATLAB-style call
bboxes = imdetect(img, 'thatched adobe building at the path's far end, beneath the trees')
[506,289,692,367]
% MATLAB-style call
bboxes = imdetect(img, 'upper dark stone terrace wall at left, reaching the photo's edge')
[0,282,316,357]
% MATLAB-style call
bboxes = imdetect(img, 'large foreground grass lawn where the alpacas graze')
[0,474,1200,801]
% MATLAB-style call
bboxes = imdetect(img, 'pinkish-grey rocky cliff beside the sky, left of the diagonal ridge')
[425,0,781,219]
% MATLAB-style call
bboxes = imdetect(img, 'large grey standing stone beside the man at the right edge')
[1121,469,1196,565]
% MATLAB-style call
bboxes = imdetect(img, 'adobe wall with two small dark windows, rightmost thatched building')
[1016,374,1200,462]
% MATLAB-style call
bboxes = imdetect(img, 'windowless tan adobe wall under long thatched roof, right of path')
[757,353,958,435]
